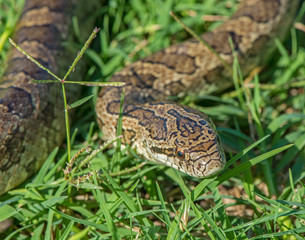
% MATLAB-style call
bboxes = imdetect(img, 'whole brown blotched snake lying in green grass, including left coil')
[0,0,298,193]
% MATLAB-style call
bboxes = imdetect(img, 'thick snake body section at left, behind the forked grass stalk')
[0,0,97,195]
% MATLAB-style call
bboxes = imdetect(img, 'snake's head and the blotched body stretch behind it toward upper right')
[96,0,298,177]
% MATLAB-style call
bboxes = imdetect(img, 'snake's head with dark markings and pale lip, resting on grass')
[139,103,226,178]
